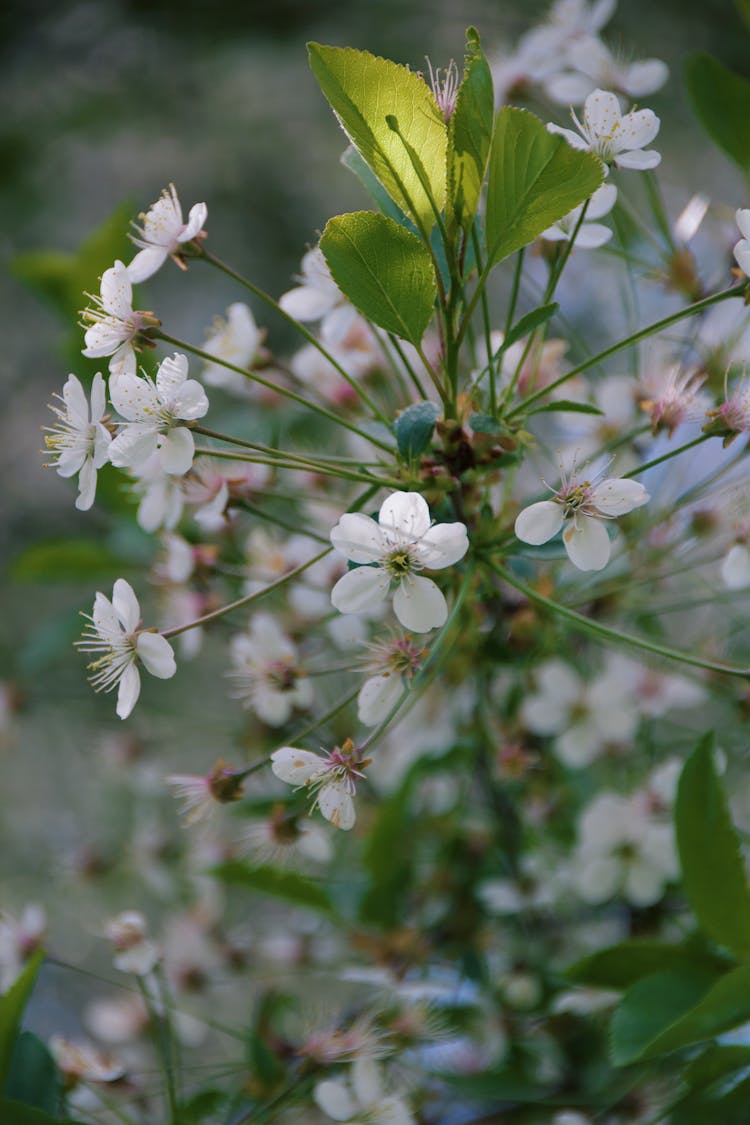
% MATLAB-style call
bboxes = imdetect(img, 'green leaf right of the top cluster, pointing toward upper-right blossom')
[487,106,604,266]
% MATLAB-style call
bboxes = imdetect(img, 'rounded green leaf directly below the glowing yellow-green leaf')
[320,212,436,344]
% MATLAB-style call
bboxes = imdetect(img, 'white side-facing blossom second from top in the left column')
[81,261,159,377]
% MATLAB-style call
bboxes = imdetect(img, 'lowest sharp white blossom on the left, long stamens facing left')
[78,578,177,719]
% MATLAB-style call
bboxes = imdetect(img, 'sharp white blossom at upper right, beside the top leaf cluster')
[548,90,661,171]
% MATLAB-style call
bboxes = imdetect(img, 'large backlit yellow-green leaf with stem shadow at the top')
[308,43,448,231]
